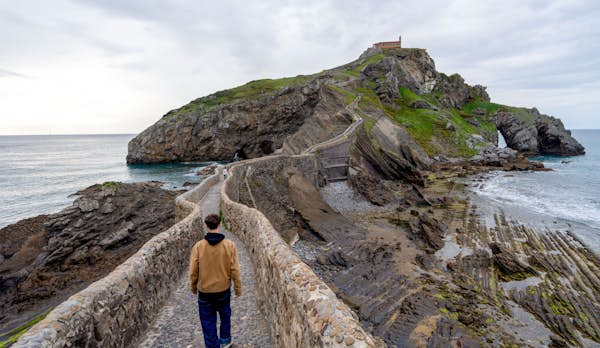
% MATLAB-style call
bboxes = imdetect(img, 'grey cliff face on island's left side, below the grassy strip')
[127,78,326,163]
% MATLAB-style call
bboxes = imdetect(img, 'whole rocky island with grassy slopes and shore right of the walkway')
[127,46,600,347]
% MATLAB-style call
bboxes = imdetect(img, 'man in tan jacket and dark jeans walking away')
[190,214,242,348]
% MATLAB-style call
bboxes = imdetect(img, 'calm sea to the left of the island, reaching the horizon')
[0,135,220,228]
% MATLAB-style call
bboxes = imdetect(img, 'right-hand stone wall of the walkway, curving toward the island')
[221,155,379,348]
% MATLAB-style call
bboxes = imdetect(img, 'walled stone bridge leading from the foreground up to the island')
[15,98,382,348]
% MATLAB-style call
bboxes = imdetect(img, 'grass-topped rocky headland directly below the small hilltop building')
[127,48,584,163]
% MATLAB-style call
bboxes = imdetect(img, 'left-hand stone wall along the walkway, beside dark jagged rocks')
[14,170,221,347]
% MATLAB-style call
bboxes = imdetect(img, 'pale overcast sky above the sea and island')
[0,0,600,134]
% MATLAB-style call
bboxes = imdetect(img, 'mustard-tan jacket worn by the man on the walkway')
[190,235,242,296]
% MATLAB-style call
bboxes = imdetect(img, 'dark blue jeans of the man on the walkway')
[198,289,231,348]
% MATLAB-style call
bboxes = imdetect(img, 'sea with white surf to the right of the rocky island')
[474,130,600,253]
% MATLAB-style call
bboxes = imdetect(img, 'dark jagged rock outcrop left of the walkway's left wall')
[0,182,176,331]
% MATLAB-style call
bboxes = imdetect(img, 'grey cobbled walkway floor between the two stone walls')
[138,180,272,348]
